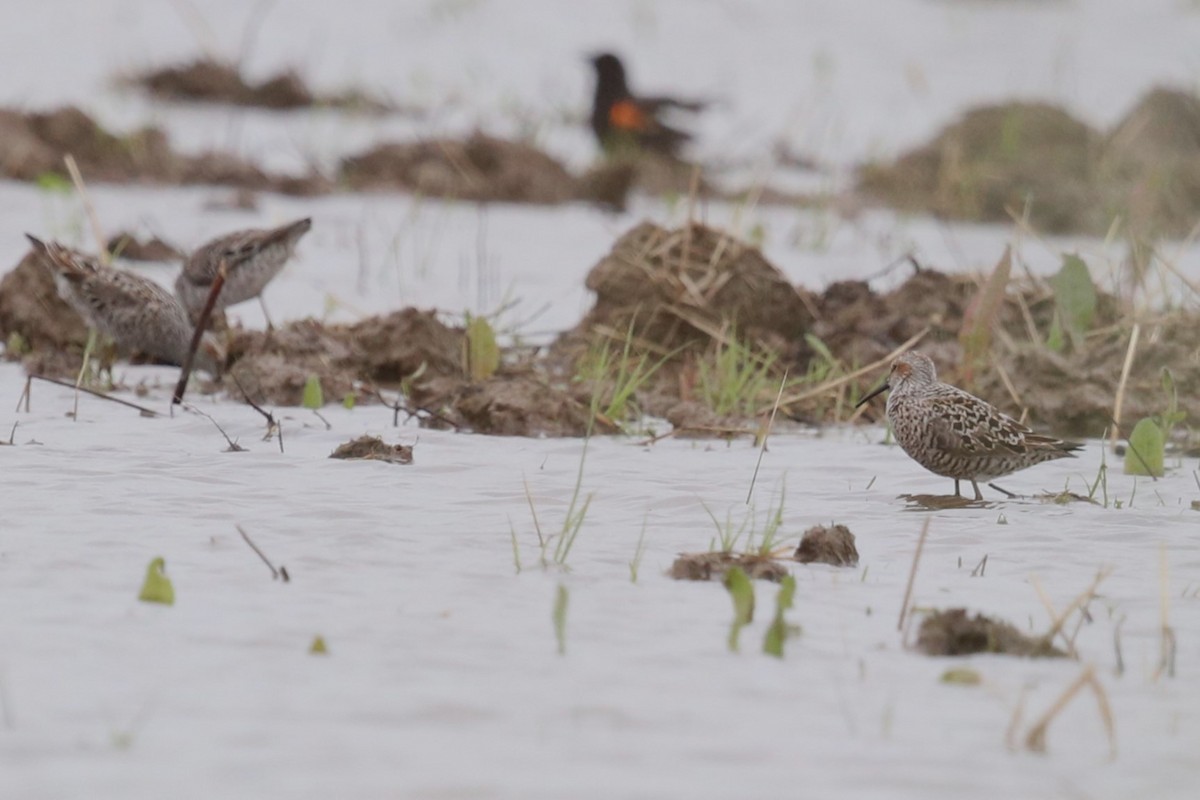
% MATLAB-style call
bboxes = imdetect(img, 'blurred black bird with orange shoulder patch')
[592,53,707,157]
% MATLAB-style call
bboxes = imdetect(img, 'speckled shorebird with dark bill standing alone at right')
[858,351,1082,500]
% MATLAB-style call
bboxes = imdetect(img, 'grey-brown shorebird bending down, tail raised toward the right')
[175,217,312,325]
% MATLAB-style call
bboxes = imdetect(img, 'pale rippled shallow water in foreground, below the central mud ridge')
[0,366,1200,796]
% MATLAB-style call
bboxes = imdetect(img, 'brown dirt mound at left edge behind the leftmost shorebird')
[0,251,88,357]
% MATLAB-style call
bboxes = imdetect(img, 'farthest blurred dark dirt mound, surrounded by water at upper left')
[135,58,390,110]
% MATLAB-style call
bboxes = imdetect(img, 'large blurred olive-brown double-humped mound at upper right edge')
[858,89,1200,235]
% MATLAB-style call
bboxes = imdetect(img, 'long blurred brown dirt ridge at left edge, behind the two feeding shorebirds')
[0,107,330,194]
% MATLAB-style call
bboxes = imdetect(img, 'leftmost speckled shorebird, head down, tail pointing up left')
[25,234,224,375]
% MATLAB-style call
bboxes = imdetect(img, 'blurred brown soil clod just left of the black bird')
[342,132,578,205]
